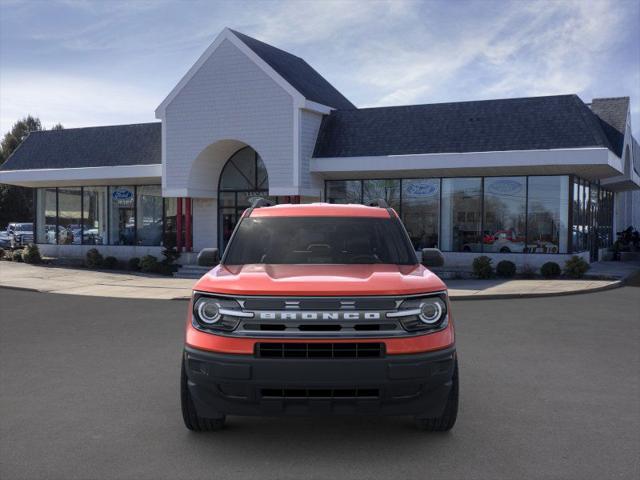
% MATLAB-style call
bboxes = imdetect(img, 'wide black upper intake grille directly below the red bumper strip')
[256,342,384,358]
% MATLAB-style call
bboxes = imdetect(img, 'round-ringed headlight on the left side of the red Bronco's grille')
[193,293,253,331]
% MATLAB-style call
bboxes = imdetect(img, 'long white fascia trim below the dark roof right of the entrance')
[310,148,622,176]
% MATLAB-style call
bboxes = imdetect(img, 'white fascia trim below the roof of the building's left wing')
[0,164,162,187]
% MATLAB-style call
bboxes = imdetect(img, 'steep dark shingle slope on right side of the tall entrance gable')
[231,30,356,109]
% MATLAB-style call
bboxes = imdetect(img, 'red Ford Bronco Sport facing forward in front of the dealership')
[181,199,458,431]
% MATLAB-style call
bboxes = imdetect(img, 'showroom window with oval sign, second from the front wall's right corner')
[482,177,527,253]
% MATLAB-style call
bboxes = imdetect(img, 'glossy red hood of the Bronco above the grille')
[194,264,447,296]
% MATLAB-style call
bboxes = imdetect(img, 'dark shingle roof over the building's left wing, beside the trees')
[0,122,162,170]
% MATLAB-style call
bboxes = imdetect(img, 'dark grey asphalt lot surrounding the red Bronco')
[0,287,640,480]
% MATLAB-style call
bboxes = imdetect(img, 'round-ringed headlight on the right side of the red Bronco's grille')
[387,293,448,331]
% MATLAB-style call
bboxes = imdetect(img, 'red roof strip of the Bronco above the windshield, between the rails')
[250,203,395,218]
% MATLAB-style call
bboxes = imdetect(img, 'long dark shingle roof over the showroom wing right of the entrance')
[314,95,611,157]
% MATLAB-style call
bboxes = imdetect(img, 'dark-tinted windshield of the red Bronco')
[224,217,418,265]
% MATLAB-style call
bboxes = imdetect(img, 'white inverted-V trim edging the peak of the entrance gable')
[155,27,304,119]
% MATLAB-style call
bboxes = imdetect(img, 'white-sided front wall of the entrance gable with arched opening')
[163,40,294,190]
